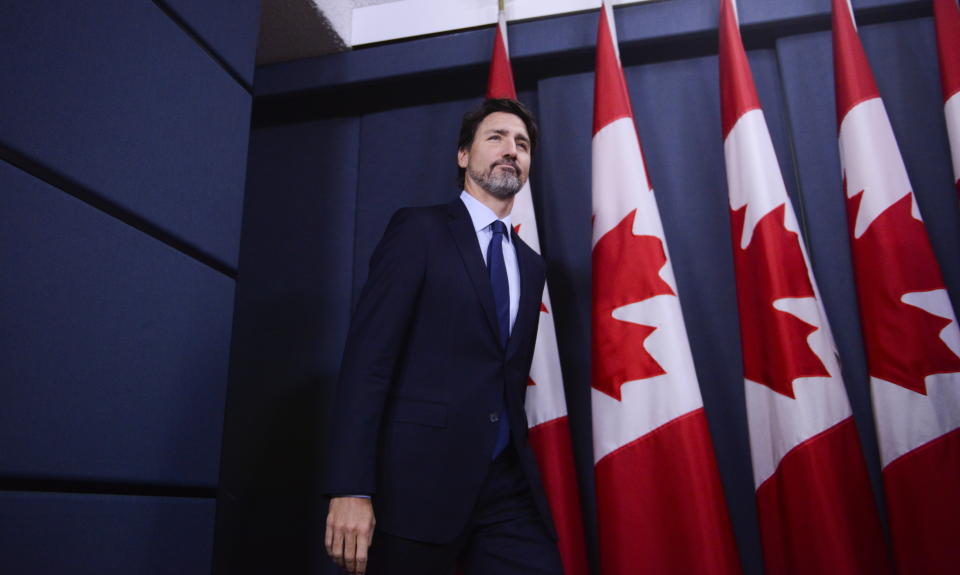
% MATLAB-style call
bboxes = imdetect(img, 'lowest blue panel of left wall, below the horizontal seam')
[0,491,214,575]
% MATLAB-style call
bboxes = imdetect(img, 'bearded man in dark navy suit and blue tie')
[325,100,562,575]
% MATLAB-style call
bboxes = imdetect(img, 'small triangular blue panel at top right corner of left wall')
[159,0,260,84]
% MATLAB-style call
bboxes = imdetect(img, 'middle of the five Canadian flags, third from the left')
[720,0,891,575]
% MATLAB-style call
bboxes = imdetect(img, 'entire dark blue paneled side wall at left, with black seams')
[0,0,259,574]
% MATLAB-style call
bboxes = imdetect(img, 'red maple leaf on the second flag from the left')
[593,210,675,401]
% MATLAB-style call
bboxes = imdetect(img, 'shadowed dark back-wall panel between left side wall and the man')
[213,119,359,575]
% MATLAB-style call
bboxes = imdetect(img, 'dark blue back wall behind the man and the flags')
[227,0,960,574]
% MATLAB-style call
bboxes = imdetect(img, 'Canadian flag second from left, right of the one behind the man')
[592,3,741,575]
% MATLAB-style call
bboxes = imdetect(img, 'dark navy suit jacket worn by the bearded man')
[324,198,556,543]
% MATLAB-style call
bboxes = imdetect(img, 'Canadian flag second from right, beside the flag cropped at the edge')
[833,0,960,574]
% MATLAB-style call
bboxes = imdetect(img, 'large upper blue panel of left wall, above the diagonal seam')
[0,0,251,267]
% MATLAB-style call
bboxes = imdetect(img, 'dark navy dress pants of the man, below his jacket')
[367,444,563,575]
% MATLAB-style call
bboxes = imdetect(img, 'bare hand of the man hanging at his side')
[324,497,377,575]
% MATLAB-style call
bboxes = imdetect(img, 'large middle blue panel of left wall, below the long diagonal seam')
[0,163,234,486]
